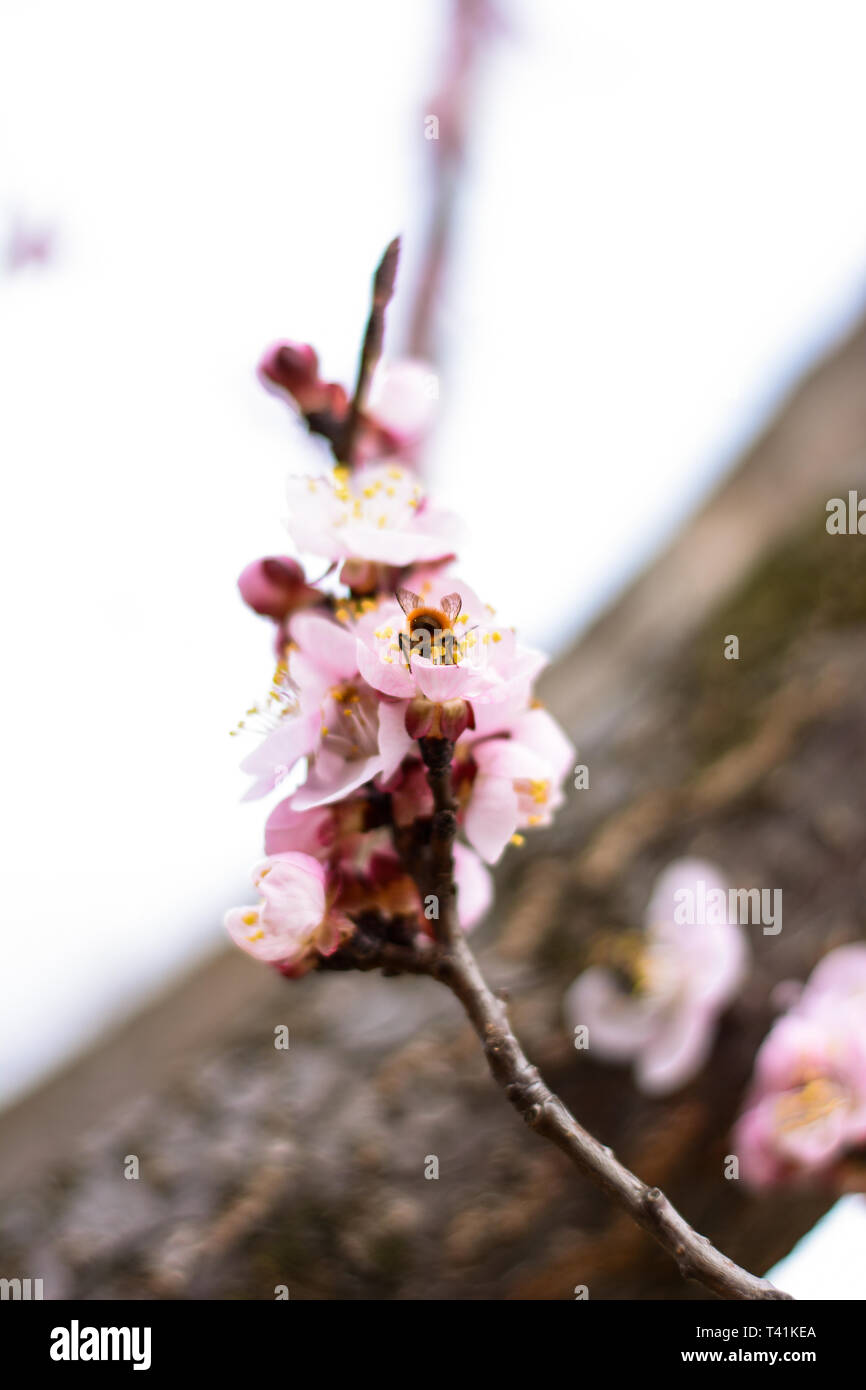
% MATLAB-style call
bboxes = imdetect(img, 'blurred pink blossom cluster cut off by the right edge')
[733,944,866,1187]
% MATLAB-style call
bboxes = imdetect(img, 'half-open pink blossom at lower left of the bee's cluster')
[225,852,353,976]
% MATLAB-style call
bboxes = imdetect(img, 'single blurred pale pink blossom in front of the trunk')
[566,859,748,1095]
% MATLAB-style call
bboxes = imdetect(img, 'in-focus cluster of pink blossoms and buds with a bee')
[227,343,574,976]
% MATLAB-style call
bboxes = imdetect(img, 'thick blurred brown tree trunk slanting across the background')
[0,309,866,1300]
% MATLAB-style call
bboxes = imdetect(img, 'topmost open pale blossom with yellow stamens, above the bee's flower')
[288,463,459,567]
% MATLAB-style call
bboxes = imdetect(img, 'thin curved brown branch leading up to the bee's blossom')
[420,738,791,1300]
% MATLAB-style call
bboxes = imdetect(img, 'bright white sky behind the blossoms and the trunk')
[0,0,866,1284]
